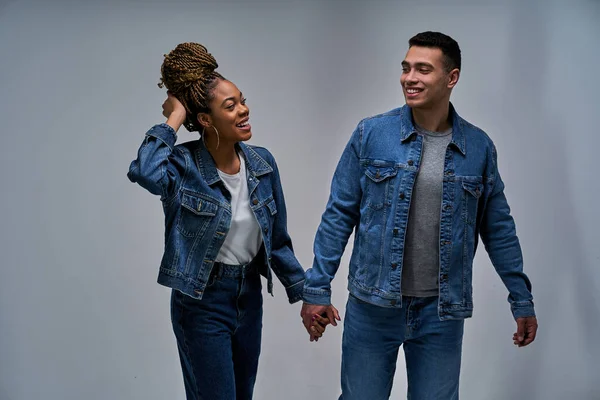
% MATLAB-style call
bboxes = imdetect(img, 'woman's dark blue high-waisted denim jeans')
[171,264,262,400]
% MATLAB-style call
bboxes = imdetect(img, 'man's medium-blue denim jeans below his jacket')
[340,295,464,400]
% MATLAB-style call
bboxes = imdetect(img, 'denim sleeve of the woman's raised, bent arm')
[127,124,187,200]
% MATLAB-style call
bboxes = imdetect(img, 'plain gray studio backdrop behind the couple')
[0,0,600,400]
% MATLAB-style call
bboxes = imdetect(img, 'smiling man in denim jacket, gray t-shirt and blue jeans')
[302,32,537,400]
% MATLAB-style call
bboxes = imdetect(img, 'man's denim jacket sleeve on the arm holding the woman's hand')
[304,123,362,305]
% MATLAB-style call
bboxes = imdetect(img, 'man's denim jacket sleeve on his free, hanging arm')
[480,147,535,318]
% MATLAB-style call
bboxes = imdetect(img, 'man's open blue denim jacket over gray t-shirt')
[304,105,535,320]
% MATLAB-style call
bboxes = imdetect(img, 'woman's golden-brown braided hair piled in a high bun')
[158,42,225,132]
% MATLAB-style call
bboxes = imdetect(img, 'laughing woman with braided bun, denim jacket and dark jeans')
[128,43,324,400]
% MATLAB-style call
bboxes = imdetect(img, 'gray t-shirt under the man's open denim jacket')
[402,125,452,297]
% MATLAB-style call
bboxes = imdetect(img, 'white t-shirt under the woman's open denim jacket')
[216,154,262,265]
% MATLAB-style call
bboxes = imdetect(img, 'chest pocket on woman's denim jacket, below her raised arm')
[177,190,219,237]
